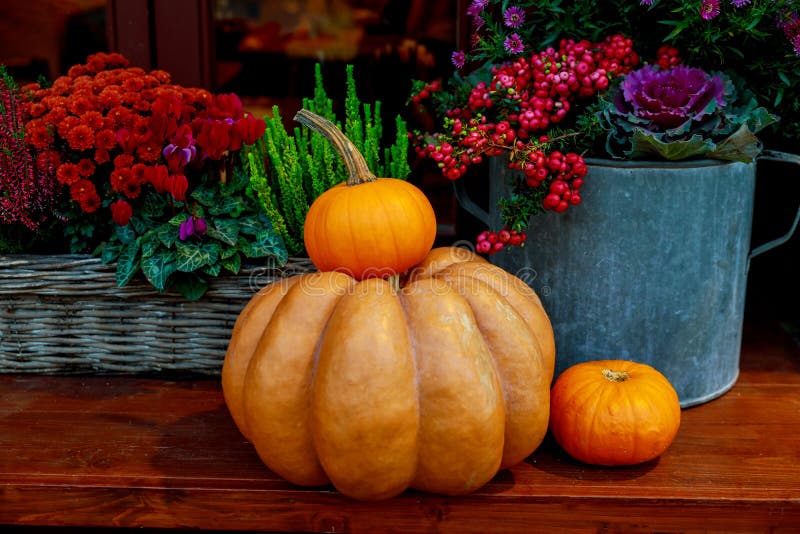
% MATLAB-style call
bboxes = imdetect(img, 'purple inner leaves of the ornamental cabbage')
[614,65,725,132]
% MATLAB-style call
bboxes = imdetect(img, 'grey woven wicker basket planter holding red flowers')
[0,255,313,375]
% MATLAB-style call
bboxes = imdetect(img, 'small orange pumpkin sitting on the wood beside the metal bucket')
[550,360,681,465]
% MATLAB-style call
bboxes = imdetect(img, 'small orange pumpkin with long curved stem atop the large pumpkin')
[295,109,436,280]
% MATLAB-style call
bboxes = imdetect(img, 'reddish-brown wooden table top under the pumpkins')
[0,325,800,533]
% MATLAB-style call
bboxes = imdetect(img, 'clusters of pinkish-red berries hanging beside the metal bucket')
[411,35,639,252]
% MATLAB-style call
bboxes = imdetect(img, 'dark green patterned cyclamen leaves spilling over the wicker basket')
[100,156,288,300]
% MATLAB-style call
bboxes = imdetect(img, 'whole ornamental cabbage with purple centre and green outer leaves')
[598,65,777,161]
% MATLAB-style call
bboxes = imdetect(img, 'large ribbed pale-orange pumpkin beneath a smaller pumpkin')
[222,248,554,500]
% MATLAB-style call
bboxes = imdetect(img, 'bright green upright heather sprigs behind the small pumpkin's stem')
[244,65,411,255]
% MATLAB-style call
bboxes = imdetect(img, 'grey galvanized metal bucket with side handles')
[456,152,800,407]
